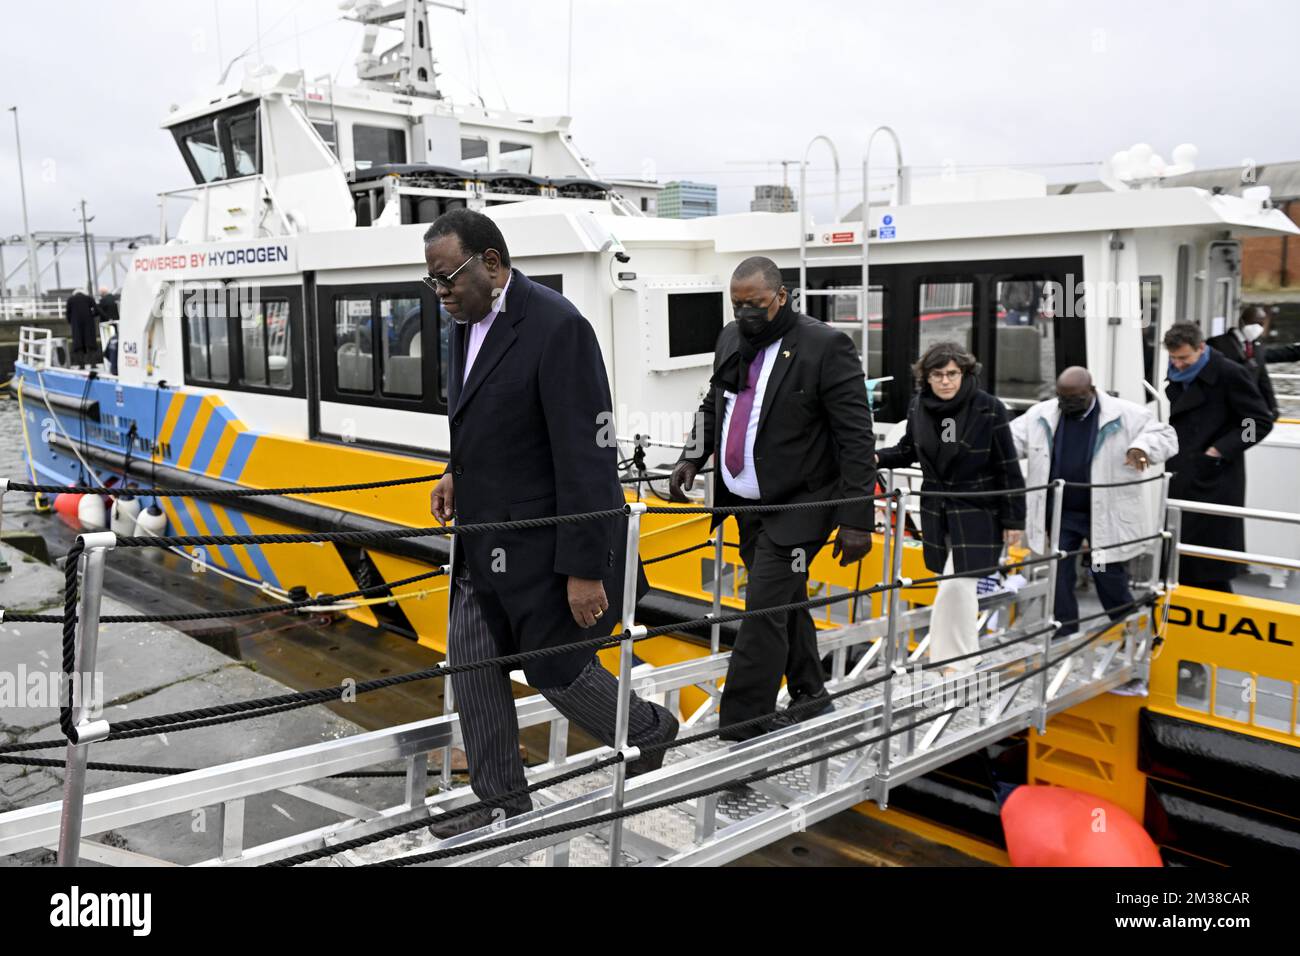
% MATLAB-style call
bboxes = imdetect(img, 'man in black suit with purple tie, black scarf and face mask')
[670,256,876,740]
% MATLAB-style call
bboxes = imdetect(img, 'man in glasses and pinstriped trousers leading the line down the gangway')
[424,209,677,838]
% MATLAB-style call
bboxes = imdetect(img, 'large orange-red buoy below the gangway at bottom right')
[1002,784,1164,866]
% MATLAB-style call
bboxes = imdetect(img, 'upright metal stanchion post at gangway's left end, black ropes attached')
[59,531,117,866]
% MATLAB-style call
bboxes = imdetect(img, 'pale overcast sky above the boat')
[0,0,1300,243]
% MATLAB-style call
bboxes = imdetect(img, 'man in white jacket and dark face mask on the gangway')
[1011,365,1178,635]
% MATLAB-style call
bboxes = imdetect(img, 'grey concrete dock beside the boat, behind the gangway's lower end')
[0,545,418,865]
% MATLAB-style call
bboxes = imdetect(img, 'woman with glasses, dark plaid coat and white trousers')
[876,342,1024,671]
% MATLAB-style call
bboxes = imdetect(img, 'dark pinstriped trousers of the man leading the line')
[447,564,668,813]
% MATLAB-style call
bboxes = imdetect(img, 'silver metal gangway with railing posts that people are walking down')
[0,476,1179,866]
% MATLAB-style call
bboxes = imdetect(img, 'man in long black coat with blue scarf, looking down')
[1165,323,1273,591]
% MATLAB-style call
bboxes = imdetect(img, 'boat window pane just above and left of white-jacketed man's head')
[993,276,1067,405]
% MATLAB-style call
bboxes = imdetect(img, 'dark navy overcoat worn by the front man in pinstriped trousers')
[447,269,649,688]
